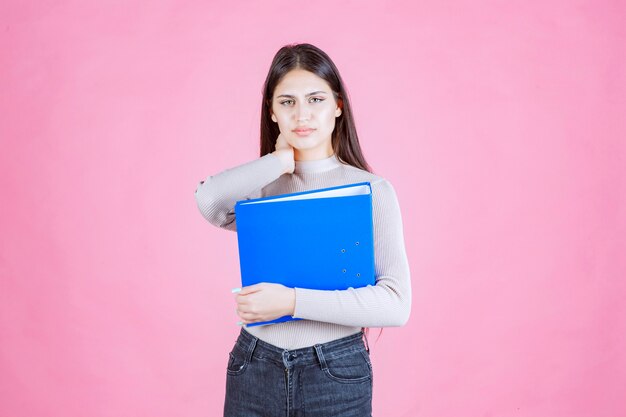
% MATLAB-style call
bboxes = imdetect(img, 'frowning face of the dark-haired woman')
[271,69,341,160]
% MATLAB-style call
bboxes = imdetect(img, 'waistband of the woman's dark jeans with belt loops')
[236,328,368,367]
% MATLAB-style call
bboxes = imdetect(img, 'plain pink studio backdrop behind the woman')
[0,0,626,417]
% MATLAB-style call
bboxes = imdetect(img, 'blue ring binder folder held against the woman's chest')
[235,182,376,326]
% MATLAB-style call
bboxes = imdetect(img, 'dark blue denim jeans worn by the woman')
[224,328,373,417]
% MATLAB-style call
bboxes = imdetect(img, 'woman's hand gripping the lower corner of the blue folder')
[236,282,296,324]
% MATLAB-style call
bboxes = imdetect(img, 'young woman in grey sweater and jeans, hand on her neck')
[195,43,411,417]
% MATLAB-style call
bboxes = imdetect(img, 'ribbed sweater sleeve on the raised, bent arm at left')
[195,154,283,231]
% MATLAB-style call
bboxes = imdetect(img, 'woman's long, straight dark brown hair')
[260,43,372,172]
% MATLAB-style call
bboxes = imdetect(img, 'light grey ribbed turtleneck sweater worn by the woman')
[195,154,411,349]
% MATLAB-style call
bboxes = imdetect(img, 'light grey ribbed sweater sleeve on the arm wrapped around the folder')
[293,179,411,327]
